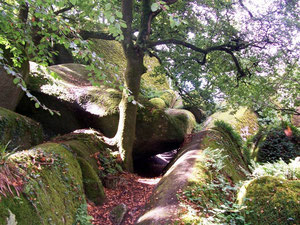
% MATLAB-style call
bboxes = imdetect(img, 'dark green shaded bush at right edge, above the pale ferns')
[257,124,300,162]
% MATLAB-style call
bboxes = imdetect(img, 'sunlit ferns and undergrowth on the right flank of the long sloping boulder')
[177,148,247,225]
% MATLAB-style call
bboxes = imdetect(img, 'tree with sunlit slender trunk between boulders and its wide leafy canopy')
[0,0,299,171]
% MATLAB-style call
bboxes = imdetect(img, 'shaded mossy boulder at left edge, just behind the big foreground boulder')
[0,107,43,150]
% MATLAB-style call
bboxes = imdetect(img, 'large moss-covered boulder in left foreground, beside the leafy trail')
[0,130,111,225]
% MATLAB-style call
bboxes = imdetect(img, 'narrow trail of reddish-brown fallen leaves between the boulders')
[88,173,161,225]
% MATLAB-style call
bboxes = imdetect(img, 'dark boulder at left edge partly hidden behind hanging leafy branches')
[0,45,29,111]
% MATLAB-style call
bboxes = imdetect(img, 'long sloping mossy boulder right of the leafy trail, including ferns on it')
[137,125,248,225]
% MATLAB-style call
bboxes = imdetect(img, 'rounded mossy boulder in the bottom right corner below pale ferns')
[239,176,300,225]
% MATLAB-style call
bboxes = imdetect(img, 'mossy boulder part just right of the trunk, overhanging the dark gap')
[133,107,196,159]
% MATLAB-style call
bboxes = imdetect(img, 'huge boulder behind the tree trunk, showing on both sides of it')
[18,64,194,158]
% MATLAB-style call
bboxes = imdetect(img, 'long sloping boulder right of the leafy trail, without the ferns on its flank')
[137,125,248,225]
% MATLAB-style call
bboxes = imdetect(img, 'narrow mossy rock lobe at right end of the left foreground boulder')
[77,157,105,205]
